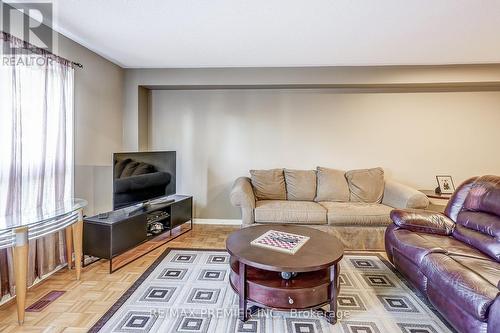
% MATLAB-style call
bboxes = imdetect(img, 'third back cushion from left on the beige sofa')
[314,167,349,202]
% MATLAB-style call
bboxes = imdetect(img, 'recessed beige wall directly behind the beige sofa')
[150,89,500,218]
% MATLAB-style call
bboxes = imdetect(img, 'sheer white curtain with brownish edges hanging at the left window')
[0,32,74,295]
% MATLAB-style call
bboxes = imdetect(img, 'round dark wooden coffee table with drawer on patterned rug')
[226,225,344,324]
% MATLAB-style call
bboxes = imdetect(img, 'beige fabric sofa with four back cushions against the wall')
[230,167,429,250]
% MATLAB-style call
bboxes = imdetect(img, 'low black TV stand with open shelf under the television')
[83,195,193,273]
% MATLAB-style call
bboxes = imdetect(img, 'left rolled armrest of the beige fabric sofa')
[230,177,255,226]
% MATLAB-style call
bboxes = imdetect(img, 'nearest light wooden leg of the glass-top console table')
[13,227,29,325]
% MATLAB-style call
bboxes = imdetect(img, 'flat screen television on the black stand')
[113,151,176,210]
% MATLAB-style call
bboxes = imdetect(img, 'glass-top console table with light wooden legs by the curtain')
[0,198,87,324]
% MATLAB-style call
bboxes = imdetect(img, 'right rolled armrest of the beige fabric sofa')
[382,180,429,209]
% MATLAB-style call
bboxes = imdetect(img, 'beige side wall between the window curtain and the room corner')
[56,36,124,214]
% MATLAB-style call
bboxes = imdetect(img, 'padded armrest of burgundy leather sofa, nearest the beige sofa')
[391,209,455,235]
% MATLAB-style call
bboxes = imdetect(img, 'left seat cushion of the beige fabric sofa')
[255,200,326,224]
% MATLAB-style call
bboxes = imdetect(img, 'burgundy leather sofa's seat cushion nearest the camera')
[421,253,499,320]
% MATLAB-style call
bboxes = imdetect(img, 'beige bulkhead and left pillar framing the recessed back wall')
[123,64,500,150]
